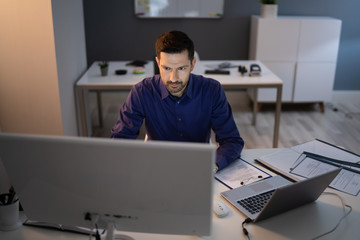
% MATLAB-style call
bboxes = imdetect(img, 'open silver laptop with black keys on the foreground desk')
[221,168,341,222]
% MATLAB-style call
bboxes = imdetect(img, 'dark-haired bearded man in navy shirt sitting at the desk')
[111,31,244,170]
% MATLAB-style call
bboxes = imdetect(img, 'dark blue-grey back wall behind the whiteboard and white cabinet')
[83,0,360,90]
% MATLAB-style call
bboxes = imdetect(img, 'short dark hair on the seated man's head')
[155,31,194,61]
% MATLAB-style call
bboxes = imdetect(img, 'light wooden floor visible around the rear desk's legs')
[90,91,360,154]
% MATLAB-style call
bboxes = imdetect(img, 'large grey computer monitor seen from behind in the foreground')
[0,134,216,236]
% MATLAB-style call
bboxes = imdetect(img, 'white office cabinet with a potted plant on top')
[249,16,341,107]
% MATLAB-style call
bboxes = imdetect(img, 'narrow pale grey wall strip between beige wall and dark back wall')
[52,0,87,136]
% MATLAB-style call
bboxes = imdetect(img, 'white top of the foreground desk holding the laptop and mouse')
[0,149,360,240]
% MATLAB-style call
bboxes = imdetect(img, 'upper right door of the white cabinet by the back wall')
[298,18,341,62]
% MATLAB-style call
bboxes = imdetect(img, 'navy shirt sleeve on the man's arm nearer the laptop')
[212,83,244,170]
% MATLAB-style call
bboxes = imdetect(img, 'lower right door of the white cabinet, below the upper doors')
[294,62,336,102]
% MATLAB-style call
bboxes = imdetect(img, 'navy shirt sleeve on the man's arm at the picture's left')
[111,85,144,139]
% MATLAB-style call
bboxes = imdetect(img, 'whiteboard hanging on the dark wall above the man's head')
[134,0,224,18]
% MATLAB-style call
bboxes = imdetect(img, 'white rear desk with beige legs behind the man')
[76,60,283,147]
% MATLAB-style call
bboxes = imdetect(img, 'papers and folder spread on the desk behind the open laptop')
[257,139,360,195]
